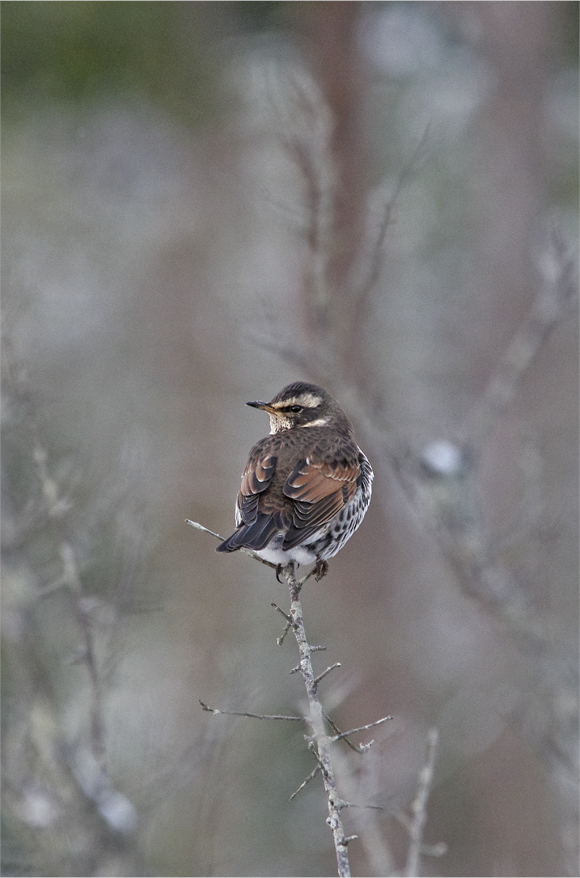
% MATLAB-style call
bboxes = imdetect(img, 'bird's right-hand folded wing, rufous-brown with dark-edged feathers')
[284,455,361,549]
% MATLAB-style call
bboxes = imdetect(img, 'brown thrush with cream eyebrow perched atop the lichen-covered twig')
[216,381,373,579]
